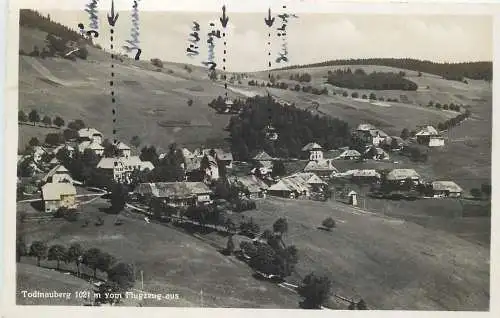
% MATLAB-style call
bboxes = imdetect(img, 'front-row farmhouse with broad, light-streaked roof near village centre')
[268,172,327,199]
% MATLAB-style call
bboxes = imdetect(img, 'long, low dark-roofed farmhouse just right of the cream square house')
[134,182,213,207]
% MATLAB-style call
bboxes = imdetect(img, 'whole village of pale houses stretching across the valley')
[18,111,463,219]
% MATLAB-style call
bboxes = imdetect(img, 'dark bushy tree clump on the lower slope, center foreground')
[232,218,298,278]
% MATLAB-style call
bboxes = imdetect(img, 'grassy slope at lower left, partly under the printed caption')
[18,201,298,308]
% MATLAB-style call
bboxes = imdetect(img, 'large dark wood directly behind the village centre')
[228,96,351,160]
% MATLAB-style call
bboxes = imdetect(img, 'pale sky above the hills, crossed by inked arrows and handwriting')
[41,10,493,72]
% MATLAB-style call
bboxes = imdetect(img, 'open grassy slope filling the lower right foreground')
[208,198,489,310]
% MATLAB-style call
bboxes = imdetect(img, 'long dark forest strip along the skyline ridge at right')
[280,58,493,81]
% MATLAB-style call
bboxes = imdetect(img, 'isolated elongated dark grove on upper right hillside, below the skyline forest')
[327,68,418,91]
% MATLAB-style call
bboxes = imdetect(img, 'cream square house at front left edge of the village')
[42,183,76,212]
